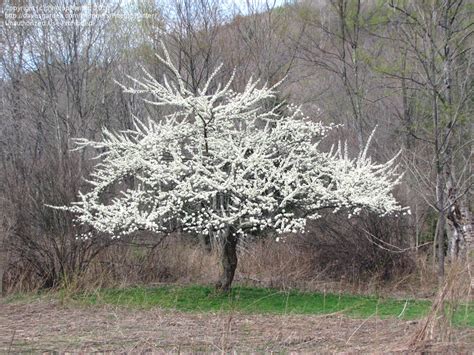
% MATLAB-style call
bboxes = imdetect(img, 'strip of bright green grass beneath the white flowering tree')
[74,286,474,327]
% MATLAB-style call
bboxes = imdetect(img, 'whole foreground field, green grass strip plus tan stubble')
[0,285,474,353]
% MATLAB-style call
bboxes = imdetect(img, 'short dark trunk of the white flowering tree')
[216,227,238,292]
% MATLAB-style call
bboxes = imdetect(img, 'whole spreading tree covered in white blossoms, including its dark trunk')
[57,48,402,291]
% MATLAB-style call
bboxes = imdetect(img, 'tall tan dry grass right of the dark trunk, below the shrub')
[236,236,437,298]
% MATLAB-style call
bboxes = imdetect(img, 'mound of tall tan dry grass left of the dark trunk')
[74,235,219,289]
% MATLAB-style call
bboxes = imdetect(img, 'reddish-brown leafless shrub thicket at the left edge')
[2,155,114,290]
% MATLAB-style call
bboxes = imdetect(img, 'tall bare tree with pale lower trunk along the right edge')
[386,0,474,276]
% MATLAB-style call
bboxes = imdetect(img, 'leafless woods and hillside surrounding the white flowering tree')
[0,0,474,294]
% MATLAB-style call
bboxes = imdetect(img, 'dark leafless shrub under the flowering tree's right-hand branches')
[302,215,415,281]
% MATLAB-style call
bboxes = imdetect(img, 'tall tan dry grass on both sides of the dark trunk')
[6,236,437,298]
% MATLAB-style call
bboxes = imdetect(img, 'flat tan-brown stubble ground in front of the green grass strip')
[0,300,474,353]
